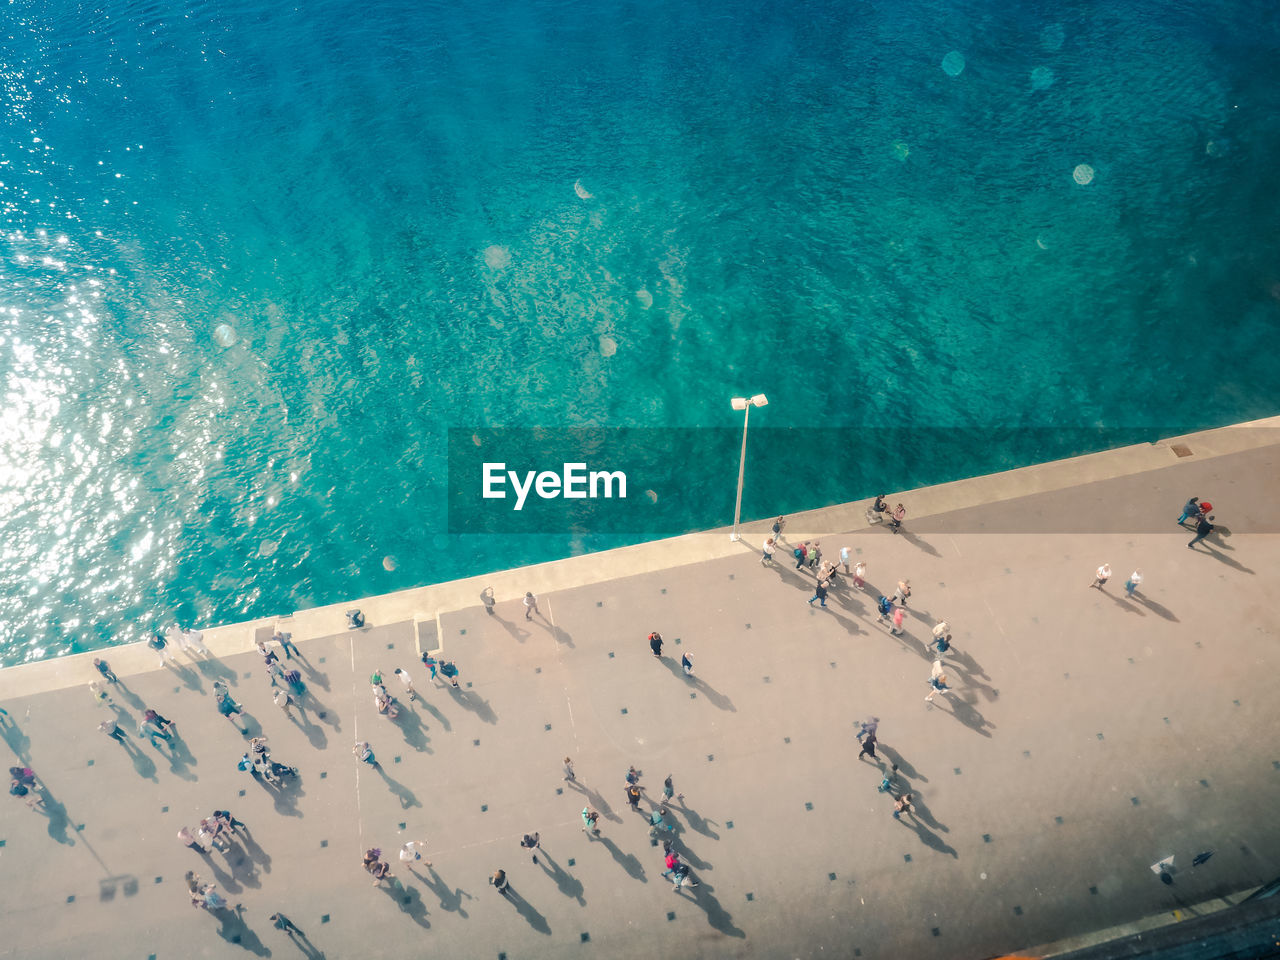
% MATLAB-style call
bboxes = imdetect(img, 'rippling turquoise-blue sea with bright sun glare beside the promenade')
[0,0,1280,664]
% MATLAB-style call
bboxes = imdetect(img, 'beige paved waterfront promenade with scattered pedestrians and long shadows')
[0,420,1280,960]
